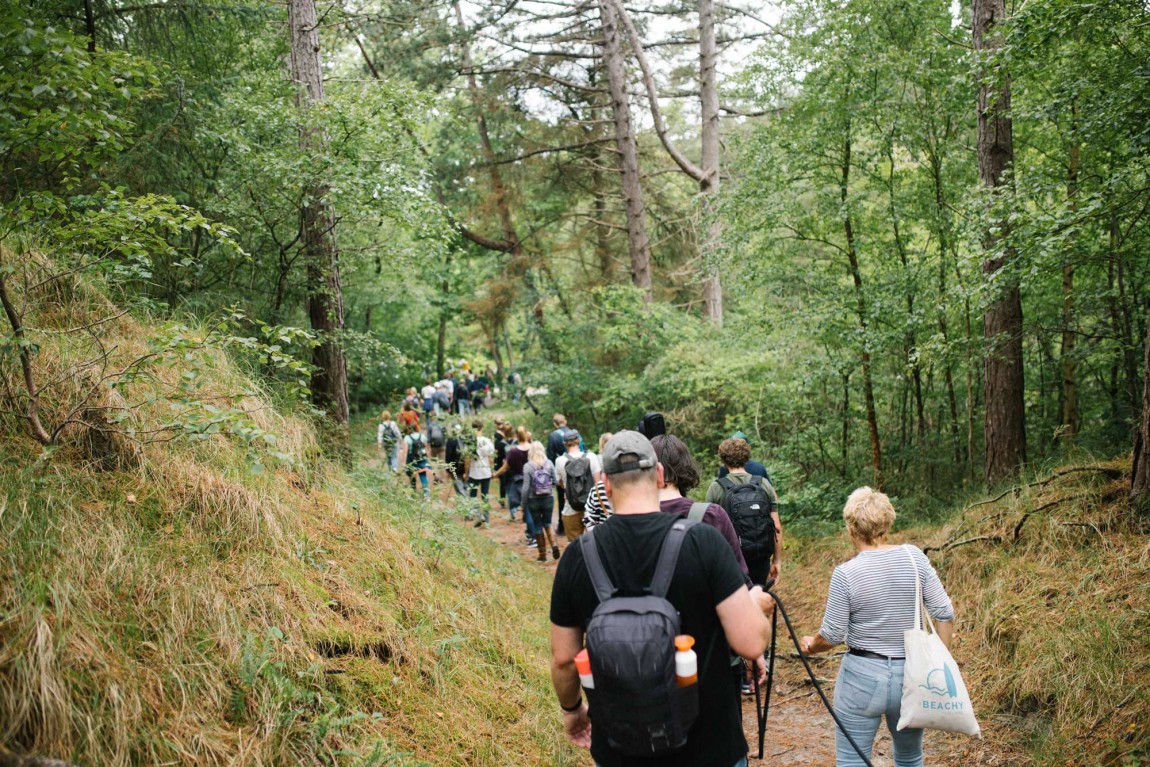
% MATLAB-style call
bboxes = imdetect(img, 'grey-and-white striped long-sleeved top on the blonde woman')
[819,545,955,658]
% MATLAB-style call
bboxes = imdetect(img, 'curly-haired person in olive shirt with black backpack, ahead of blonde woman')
[706,439,783,584]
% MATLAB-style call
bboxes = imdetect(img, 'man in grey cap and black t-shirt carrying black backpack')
[551,431,774,767]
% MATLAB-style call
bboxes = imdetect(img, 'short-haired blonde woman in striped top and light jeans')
[799,488,955,767]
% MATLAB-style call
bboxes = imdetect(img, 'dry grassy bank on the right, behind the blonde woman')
[780,463,1150,767]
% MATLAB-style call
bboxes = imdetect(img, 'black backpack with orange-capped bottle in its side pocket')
[580,520,699,757]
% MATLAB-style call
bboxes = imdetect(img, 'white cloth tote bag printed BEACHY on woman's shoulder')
[898,547,982,737]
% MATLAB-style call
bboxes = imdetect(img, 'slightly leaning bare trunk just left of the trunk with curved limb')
[599,0,652,304]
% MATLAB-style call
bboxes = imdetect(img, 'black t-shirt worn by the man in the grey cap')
[551,509,746,767]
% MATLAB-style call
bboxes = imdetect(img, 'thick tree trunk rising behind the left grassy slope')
[288,0,348,424]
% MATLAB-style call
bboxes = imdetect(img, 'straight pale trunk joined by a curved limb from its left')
[699,0,722,328]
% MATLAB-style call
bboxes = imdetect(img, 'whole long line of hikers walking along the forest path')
[380,390,955,767]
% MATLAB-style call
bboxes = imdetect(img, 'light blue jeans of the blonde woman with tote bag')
[835,654,922,767]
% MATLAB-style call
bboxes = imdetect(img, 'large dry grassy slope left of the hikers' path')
[0,333,578,767]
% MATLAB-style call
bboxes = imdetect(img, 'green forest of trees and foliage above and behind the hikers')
[0,0,1150,516]
